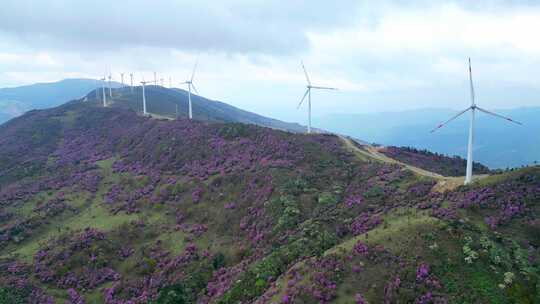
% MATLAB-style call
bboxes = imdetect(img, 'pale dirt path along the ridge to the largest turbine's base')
[341,137,489,192]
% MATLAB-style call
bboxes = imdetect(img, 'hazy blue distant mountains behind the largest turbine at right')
[317,107,540,168]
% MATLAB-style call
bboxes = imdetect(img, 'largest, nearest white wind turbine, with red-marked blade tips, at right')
[431,58,521,185]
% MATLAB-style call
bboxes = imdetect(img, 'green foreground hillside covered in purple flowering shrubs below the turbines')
[0,102,540,303]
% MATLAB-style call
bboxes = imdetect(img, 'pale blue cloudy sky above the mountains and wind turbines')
[0,0,540,121]
